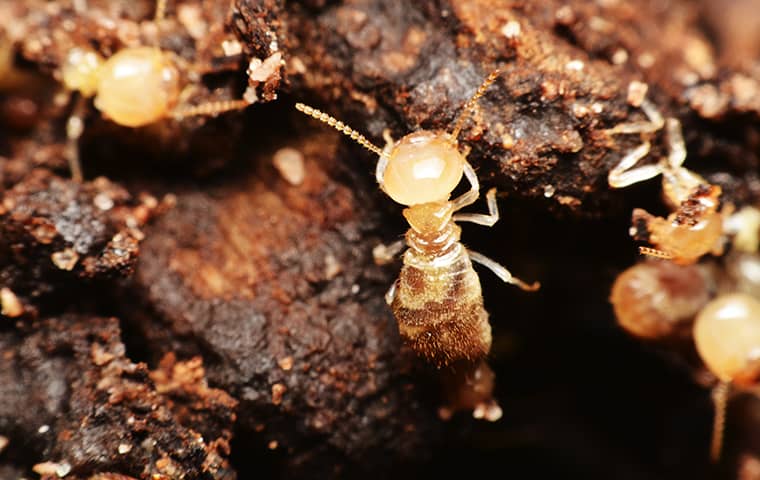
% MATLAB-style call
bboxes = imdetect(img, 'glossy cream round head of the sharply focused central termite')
[382,130,465,206]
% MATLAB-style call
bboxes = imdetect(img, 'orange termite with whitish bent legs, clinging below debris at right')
[607,96,728,264]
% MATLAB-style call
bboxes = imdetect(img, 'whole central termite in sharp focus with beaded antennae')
[296,70,539,420]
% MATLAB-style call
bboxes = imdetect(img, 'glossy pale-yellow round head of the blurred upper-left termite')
[95,47,180,127]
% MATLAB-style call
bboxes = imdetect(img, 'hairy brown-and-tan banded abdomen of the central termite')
[391,242,491,366]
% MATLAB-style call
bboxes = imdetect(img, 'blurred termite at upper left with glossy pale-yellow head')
[61,0,251,181]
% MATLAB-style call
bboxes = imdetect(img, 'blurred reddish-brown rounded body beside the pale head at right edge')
[610,261,712,340]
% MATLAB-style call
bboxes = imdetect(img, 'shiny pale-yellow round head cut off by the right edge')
[694,293,760,386]
